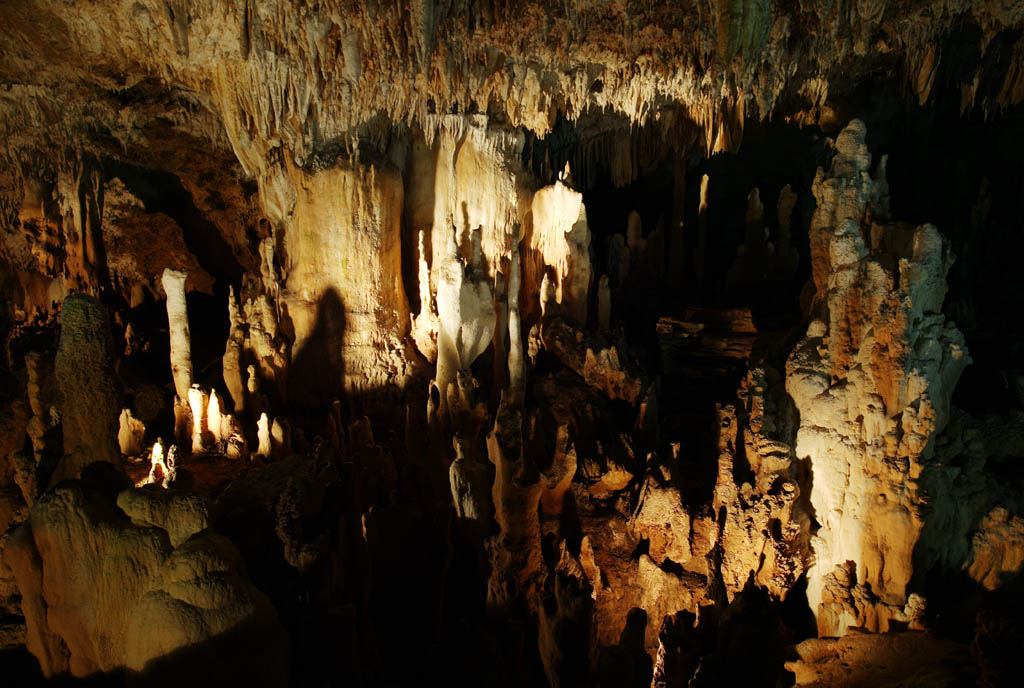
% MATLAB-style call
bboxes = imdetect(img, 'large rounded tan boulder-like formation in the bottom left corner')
[5,482,286,685]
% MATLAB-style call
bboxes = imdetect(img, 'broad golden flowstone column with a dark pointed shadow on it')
[280,158,412,404]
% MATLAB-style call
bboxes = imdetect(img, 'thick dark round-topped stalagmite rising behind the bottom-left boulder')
[51,294,121,483]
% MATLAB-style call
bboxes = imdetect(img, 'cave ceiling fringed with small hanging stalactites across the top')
[0,0,1024,212]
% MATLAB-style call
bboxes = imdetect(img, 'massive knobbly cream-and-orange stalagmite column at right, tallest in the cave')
[786,120,970,635]
